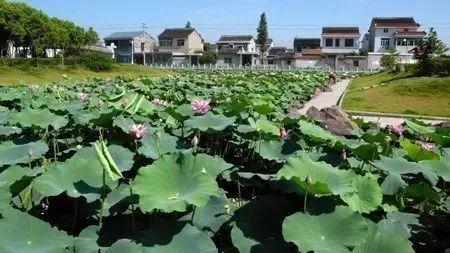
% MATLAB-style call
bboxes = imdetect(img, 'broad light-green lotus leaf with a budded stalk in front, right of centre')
[277,152,355,195]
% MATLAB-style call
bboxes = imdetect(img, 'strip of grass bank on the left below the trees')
[0,64,173,85]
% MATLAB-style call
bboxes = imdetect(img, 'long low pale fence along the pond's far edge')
[149,64,380,73]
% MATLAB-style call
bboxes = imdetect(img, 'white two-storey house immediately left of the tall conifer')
[216,35,259,66]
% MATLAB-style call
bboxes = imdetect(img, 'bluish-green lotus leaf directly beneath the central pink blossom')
[184,112,236,132]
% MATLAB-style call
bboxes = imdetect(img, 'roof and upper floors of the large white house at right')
[367,17,426,54]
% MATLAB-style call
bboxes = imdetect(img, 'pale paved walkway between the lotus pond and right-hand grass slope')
[300,79,443,127]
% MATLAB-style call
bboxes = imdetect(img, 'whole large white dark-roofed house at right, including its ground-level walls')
[362,17,426,67]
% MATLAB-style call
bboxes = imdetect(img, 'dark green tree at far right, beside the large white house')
[414,28,448,75]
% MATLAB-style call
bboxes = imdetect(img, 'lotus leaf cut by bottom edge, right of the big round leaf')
[352,220,414,253]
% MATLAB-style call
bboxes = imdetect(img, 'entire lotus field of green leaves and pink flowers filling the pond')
[0,71,450,253]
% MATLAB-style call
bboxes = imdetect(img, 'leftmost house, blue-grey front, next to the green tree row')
[104,31,156,63]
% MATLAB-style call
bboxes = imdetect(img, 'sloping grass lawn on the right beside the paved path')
[343,72,450,117]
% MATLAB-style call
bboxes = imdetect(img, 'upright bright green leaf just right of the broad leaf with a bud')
[341,174,383,213]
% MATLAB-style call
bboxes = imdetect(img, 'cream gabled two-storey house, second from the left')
[155,28,204,64]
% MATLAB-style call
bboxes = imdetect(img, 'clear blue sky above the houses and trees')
[19,0,450,47]
